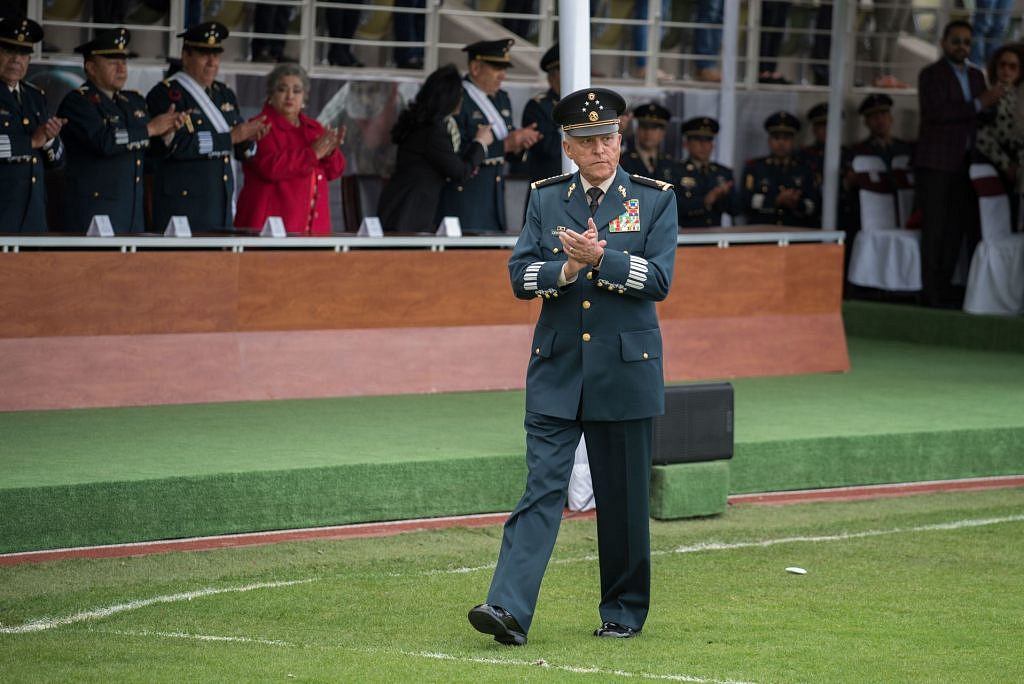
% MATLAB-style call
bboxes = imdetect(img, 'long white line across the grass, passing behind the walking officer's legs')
[0,514,1024,634]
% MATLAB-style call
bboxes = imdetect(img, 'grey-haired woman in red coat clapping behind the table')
[234,65,345,236]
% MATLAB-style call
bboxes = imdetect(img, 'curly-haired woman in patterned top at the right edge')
[975,45,1024,225]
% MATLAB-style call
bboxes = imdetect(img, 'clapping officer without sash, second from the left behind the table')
[57,29,185,233]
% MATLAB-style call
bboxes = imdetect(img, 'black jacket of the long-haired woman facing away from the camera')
[377,121,484,232]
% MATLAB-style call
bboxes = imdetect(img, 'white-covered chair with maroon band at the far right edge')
[964,164,1024,315]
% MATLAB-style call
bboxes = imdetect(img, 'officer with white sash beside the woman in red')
[145,22,266,230]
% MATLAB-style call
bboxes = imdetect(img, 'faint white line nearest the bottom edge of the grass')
[88,630,742,684]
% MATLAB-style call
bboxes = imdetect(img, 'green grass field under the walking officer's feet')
[0,489,1024,683]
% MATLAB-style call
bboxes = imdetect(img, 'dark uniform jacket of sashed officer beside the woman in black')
[434,76,515,233]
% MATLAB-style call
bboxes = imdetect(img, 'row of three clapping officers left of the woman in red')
[0,18,267,232]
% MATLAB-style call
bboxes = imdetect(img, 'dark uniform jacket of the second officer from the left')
[57,82,150,233]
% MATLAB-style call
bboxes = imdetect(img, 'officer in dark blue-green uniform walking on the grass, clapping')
[469,88,676,645]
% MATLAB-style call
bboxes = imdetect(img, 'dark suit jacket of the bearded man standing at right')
[913,57,985,171]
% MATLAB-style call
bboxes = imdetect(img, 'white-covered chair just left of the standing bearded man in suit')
[847,155,921,292]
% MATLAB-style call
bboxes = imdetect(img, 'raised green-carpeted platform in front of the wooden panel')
[0,339,1024,552]
